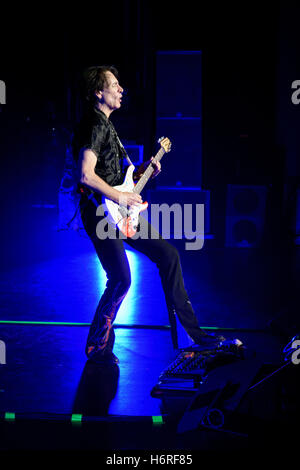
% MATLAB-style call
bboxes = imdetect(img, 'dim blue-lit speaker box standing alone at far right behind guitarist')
[225,184,267,247]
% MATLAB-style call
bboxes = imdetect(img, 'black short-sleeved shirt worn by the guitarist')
[72,108,124,186]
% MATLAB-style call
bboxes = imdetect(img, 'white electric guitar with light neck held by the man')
[103,137,171,238]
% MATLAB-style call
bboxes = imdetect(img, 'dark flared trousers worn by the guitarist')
[81,199,204,355]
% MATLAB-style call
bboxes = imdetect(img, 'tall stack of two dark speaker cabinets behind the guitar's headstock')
[156,51,202,186]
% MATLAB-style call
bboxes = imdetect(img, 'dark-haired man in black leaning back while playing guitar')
[73,66,225,362]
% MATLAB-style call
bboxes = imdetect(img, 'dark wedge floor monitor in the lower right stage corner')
[177,357,300,438]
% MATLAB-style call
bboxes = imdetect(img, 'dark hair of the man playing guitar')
[83,65,119,103]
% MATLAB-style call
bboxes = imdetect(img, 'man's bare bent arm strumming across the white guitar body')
[79,149,143,206]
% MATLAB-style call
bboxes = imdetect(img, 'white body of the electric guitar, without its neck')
[103,165,148,238]
